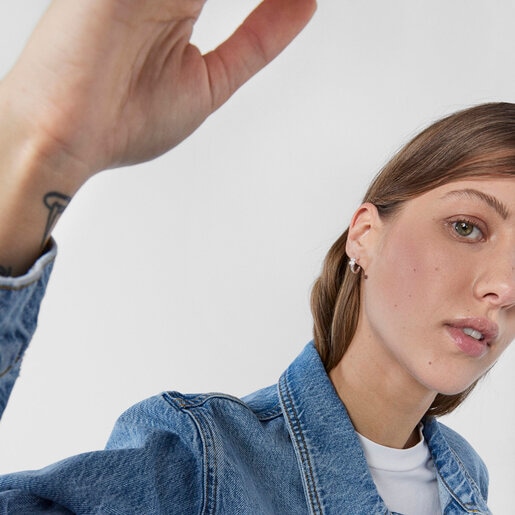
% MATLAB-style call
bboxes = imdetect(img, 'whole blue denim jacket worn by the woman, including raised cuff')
[0,248,490,515]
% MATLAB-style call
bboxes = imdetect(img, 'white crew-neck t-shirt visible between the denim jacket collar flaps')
[358,430,442,515]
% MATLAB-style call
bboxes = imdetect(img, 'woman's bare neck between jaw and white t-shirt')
[329,333,436,449]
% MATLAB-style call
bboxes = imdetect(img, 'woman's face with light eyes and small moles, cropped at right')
[358,178,515,395]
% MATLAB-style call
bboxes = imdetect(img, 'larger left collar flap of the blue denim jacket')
[278,344,388,515]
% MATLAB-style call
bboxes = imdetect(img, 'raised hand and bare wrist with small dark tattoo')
[0,0,315,275]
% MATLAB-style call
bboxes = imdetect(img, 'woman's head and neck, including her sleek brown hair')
[312,104,515,513]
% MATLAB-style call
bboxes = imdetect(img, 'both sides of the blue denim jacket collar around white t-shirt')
[278,342,490,515]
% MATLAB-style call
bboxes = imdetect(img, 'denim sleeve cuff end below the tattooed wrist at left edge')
[0,241,57,416]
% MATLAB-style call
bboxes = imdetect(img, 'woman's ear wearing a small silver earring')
[345,202,383,270]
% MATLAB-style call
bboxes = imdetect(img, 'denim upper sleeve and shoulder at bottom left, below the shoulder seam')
[0,395,204,515]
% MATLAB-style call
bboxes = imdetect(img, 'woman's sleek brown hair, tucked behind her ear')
[311,103,515,416]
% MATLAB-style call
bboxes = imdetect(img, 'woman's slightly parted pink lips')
[445,317,499,358]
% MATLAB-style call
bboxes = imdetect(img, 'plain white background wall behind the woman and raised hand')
[0,0,515,514]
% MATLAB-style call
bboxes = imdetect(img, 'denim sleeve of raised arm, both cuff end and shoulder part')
[0,244,204,515]
